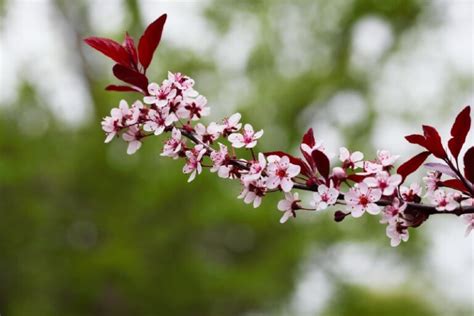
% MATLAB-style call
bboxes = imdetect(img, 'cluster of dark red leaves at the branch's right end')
[397,106,474,195]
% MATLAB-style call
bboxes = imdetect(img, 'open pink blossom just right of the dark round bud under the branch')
[344,182,382,217]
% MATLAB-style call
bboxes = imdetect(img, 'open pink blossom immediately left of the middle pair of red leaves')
[267,155,301,192]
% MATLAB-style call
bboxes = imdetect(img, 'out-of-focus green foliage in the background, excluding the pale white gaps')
[0,0,468,316]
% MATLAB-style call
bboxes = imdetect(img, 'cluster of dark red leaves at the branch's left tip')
[84,14,166,95]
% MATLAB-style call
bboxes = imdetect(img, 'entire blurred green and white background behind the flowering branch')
[0,0,474,316]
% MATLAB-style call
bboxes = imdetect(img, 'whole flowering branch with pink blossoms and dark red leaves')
[85,15,474,246]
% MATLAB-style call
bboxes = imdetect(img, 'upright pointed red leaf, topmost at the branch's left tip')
[138,14,166,70]
